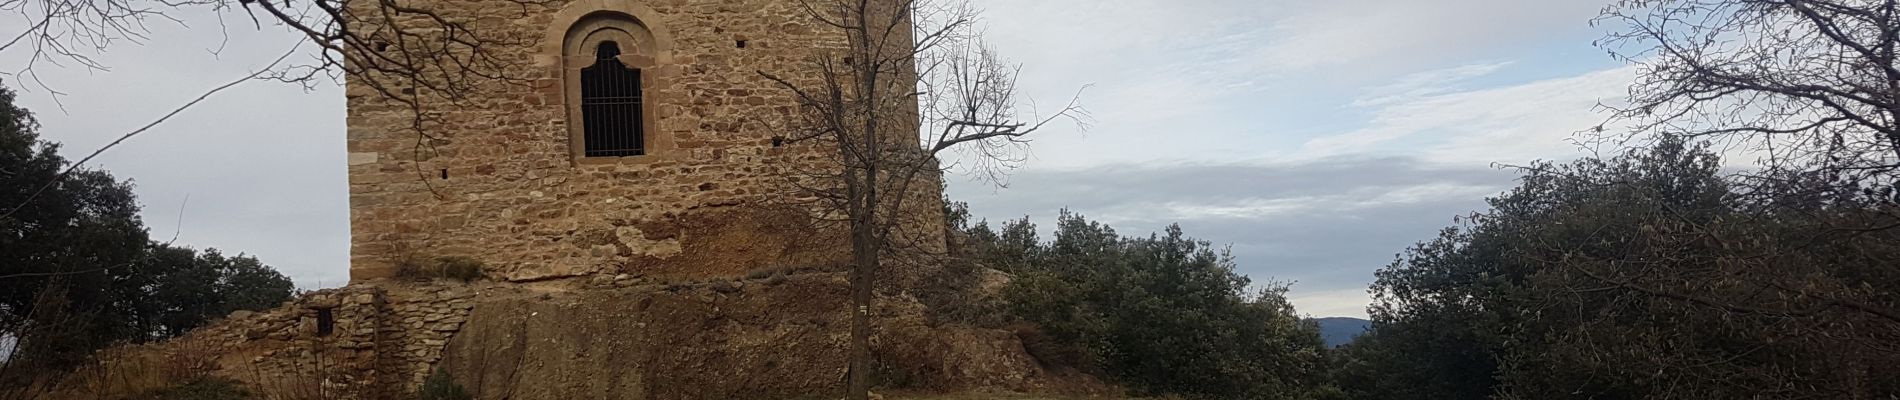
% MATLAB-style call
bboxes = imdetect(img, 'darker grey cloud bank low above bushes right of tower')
[950,157,1512,315]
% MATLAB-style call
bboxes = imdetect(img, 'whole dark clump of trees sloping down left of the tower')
[0,79,291,379]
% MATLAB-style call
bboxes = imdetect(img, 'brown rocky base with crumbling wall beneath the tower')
[92,269,1071,400]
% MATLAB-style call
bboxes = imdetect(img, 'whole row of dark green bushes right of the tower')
[923,138,1900,400]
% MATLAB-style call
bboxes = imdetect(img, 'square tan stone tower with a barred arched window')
[348,0,942,281]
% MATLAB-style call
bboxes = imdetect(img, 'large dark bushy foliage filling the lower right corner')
[1338,140,1900,398]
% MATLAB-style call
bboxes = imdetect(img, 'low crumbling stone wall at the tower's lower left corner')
[152,282,479,398]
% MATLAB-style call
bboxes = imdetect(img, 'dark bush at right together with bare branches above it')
[1334,0,1900,400]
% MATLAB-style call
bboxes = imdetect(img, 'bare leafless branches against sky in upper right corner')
[1596,0,1900,184]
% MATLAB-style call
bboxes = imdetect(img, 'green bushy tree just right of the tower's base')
[963,210,1324,398]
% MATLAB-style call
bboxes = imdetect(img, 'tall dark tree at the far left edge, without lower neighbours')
[0,80,146,375]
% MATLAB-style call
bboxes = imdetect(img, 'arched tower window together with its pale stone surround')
[561,13,657,159]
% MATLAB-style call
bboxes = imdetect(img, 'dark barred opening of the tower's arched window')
[581,42,646,157]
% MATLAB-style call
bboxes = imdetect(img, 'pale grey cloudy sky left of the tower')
[0,17,350,288]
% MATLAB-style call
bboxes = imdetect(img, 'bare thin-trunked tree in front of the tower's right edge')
[760,0,1087,400]
